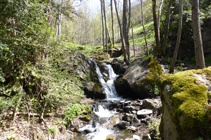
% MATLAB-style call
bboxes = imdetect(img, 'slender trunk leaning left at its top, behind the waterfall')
[114,0,127,61]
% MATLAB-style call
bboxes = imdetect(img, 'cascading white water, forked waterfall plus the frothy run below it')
[79,60,138,140]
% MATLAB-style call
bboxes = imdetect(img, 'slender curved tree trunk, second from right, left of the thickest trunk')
[169,0,184,73]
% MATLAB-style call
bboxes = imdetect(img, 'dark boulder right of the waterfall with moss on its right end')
[115,59,162,99]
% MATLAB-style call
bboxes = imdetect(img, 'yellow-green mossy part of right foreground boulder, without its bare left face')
[156,67,211,139]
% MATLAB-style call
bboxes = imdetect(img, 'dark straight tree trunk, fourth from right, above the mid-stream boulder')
[152,0,161,58]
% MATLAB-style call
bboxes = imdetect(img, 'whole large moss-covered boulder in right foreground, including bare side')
[156,67,211,140]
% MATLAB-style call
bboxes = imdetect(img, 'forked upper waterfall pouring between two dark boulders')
[92,60,122,100]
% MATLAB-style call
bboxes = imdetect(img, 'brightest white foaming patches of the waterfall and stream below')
[79,60,138,140]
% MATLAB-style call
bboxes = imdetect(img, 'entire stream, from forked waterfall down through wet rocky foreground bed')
[77,60,155,140]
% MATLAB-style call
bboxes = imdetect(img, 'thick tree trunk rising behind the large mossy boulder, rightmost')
[192,0,205,69]
